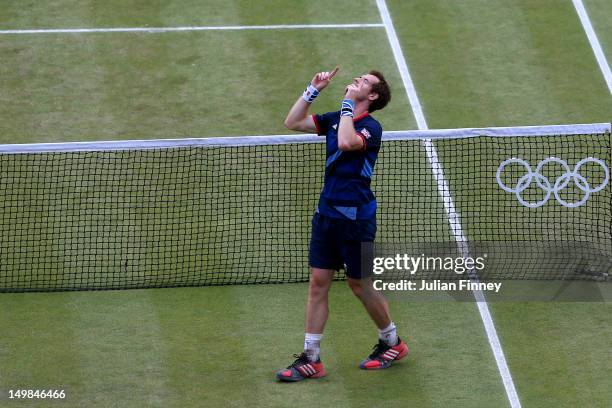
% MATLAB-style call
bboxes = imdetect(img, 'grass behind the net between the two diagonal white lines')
[389,0,612,128]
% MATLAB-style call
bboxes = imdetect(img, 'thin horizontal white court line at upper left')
[0,24,384,34]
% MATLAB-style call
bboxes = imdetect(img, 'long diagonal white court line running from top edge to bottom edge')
[376,0,521,408]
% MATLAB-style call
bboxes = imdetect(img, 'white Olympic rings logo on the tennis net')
[495,157,610,208]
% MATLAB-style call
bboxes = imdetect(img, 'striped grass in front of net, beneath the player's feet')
[0,282,504,407]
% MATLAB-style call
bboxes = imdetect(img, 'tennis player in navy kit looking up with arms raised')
[276,67,408,381]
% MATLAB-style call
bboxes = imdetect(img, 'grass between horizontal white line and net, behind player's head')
[0,29,414,143]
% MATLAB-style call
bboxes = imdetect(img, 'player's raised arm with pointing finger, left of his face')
[285,67,340,133]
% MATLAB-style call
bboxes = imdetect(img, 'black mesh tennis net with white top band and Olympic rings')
[0,124,612,292]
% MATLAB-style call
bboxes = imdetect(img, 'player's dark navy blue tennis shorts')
[308,213,376,279]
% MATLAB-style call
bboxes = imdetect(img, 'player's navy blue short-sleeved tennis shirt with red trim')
[312,111,382,220]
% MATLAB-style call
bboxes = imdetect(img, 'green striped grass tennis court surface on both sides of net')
[0,0,612,407]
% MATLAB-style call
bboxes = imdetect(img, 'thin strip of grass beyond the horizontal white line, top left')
[0,0,380,29]
